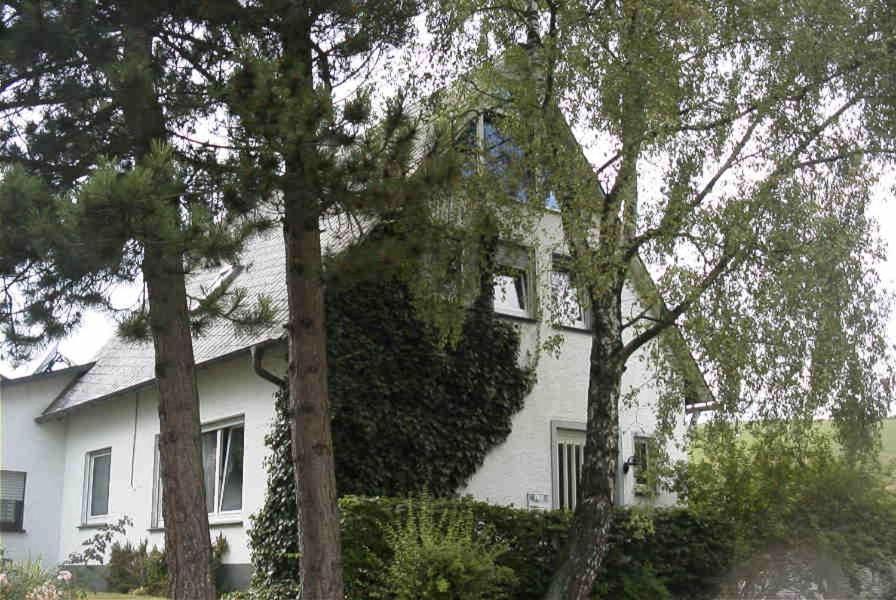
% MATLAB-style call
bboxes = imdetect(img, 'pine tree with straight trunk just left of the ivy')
[228,0,434,600]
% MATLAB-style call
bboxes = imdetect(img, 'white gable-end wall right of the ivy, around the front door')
[462,212,686,507]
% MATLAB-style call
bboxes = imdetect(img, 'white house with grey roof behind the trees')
[0,199,709,584]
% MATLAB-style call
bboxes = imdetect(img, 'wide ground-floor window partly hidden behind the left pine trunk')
[152,417,245,527]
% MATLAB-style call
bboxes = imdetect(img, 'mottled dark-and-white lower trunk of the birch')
[545,291,625,600]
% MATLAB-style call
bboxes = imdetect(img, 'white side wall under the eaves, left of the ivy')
[59,348,284,564]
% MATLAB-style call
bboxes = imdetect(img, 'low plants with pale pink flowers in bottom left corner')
[0,548,86,600]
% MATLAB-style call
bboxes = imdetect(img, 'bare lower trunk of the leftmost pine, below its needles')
[143,245,216,600]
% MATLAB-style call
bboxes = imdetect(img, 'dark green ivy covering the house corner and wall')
[249,270,534,599]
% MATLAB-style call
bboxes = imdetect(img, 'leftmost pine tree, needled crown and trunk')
[0,0,269,600]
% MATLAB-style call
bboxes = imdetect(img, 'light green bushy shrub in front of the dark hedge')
[386,496,515,600]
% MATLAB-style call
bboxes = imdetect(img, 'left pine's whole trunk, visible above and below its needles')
[117,0,216,600]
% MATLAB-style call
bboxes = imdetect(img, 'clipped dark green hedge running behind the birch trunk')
[340,496,733,600]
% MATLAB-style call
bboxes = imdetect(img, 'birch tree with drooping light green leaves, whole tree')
[430,0,896,600]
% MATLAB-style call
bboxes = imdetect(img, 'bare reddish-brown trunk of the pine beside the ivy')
[284,191,343,600]
